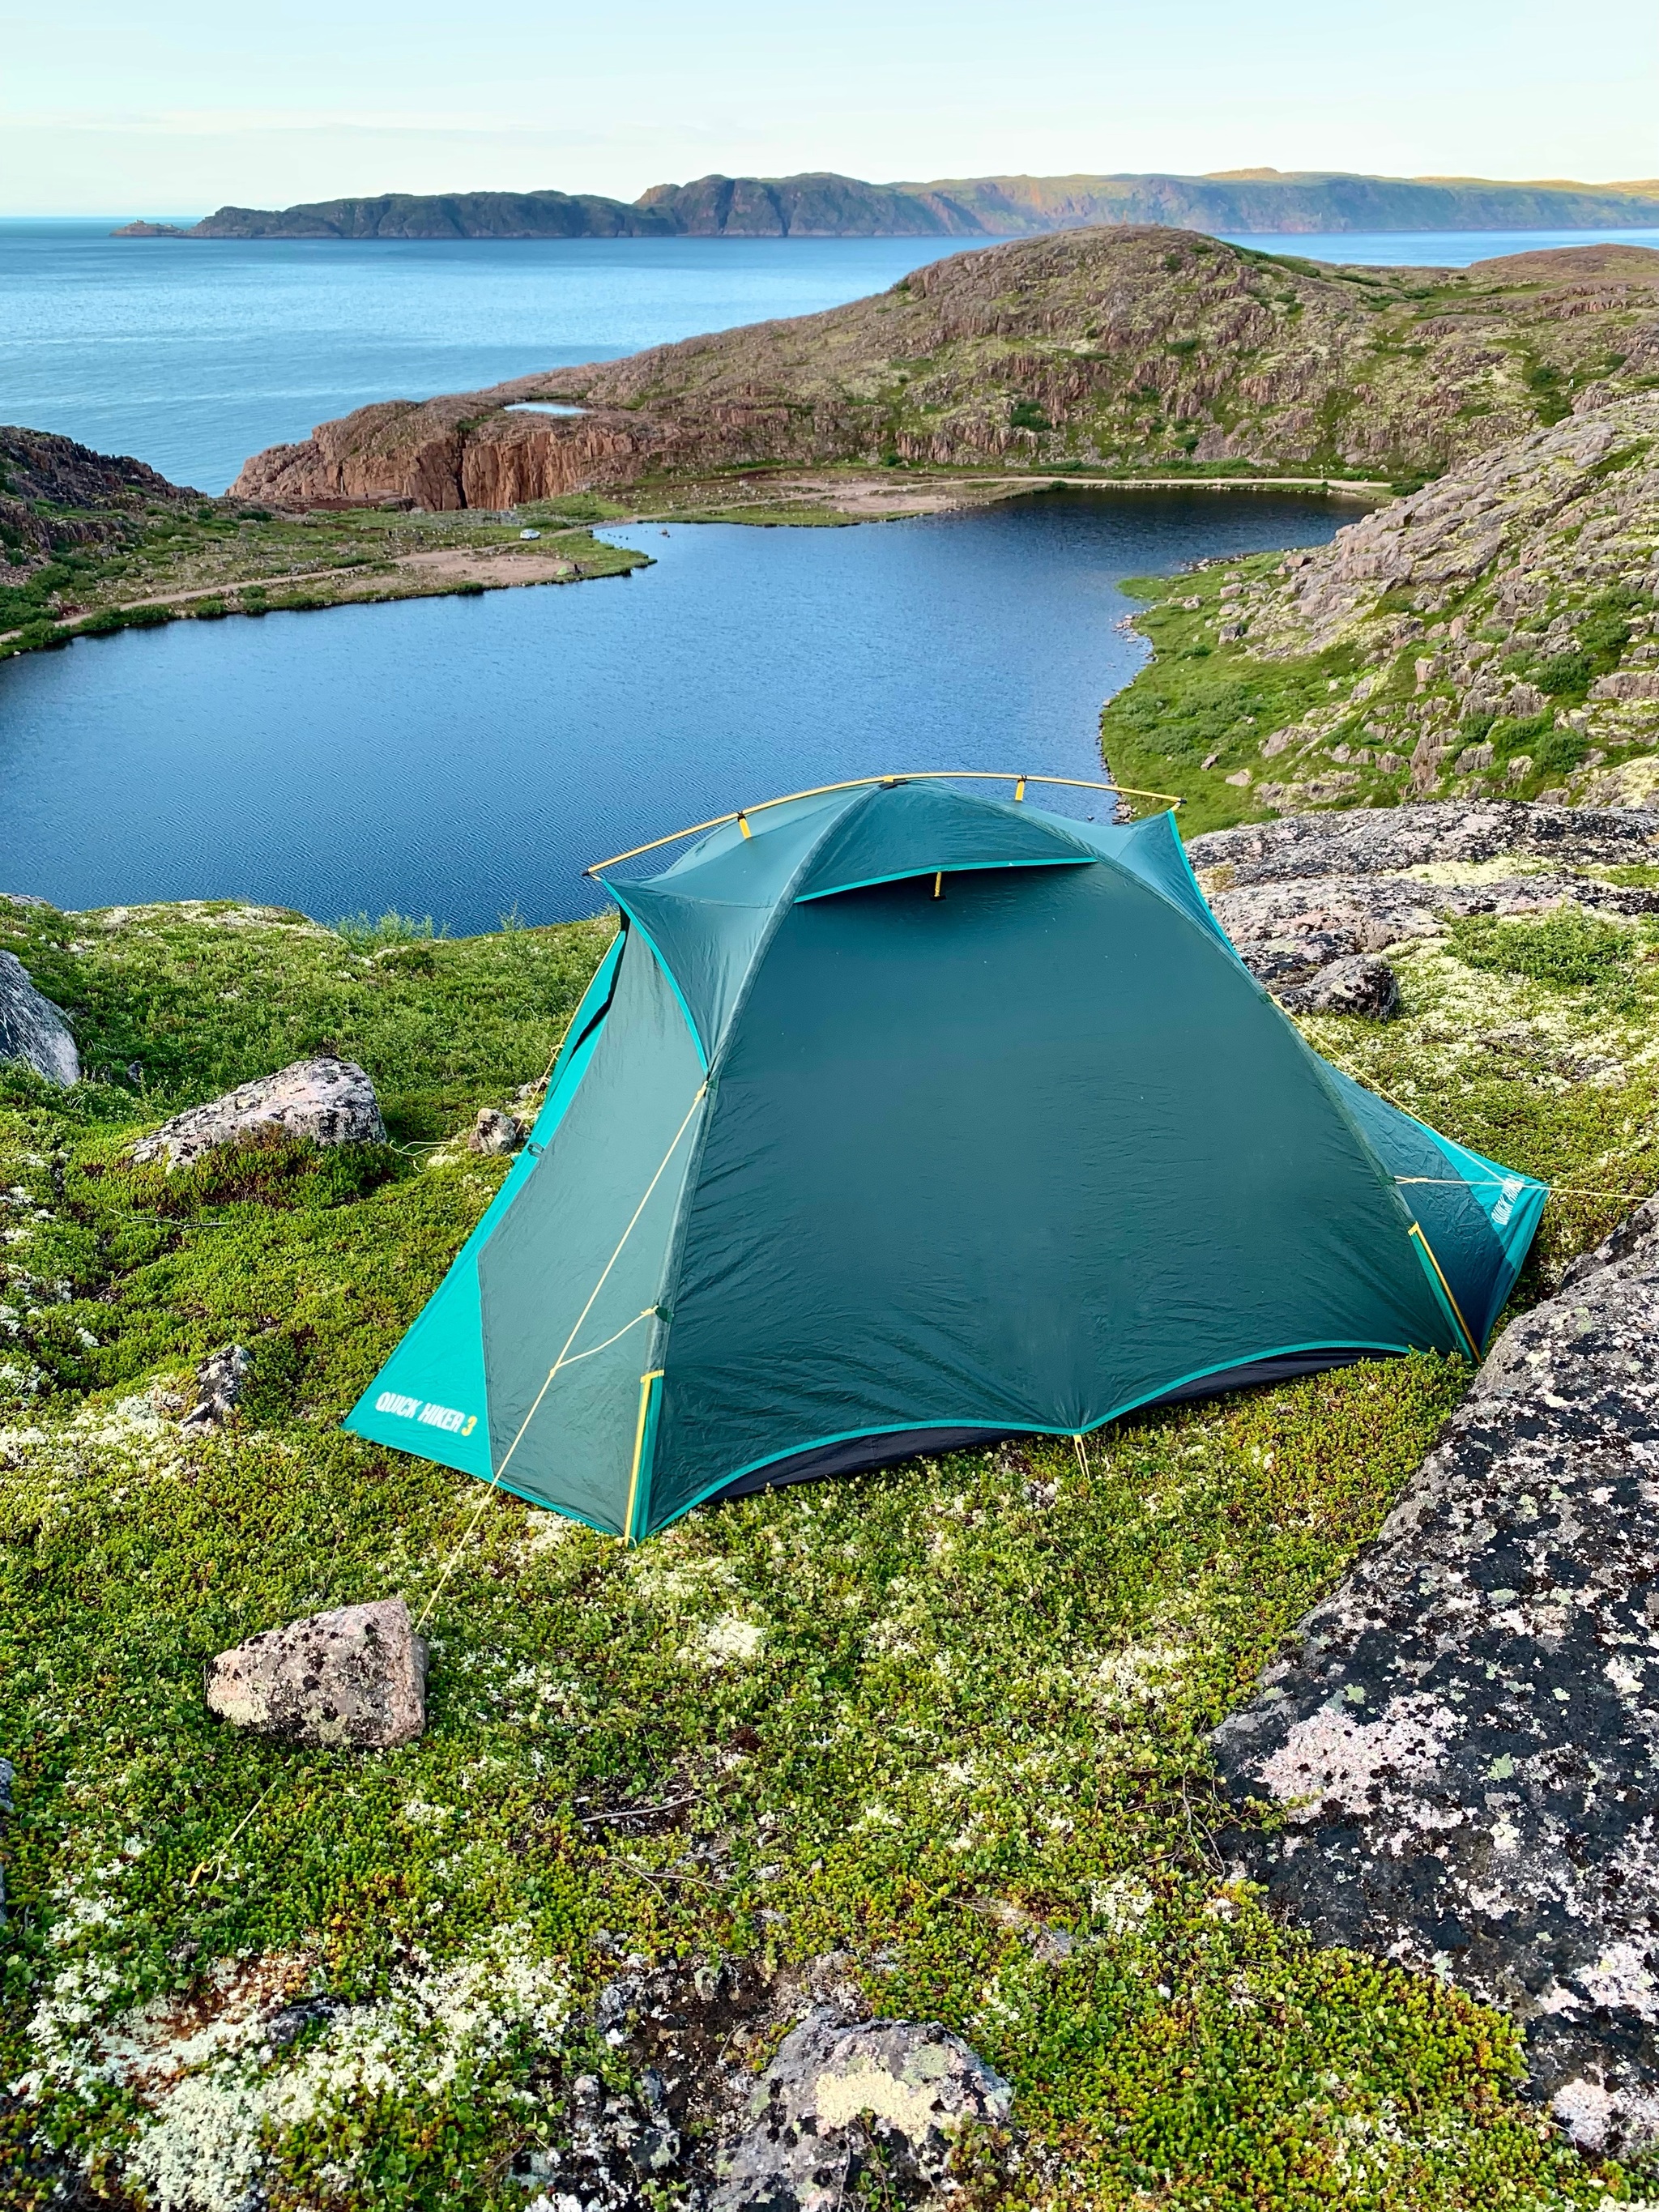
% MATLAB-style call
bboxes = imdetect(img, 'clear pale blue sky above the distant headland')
[0,0,1659,215]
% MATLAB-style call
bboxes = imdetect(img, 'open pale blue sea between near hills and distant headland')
[13,219,1659,491]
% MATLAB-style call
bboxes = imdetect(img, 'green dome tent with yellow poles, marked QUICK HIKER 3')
[348,778,1546,1542]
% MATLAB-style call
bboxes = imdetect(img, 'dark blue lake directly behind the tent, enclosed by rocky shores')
[0,493,1358,931]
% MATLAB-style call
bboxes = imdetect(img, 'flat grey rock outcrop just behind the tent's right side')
[1188,801,1659,999]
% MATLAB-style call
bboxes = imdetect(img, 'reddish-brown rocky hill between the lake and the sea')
[234,228,1659,506]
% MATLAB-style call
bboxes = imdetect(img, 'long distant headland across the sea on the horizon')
[113,168,1659,239]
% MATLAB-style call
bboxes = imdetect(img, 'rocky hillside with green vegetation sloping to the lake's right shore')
[1102,391,1659,834]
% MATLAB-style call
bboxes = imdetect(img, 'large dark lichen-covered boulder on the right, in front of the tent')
[1217,1199,1659,2150]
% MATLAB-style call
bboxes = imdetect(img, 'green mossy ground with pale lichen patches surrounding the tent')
[0,905,1659,2212]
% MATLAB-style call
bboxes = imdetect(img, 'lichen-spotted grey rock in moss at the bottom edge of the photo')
[710,2006,1013,2212]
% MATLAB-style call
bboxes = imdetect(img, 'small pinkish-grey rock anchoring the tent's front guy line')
[208,1597,427,1752]
